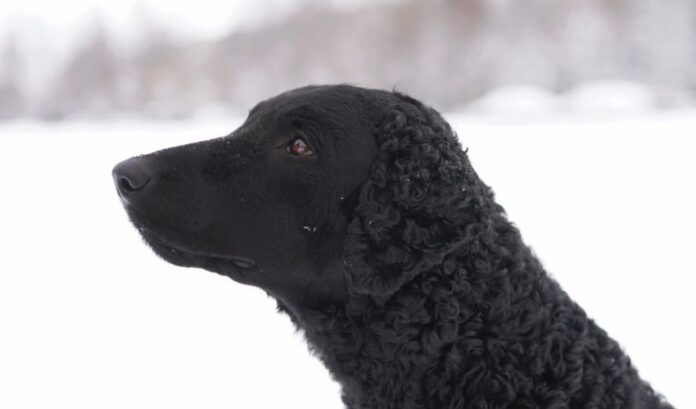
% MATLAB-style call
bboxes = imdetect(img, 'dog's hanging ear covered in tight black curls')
[344,94,493,297]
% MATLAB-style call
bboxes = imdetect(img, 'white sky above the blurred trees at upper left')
[0,0,308,95]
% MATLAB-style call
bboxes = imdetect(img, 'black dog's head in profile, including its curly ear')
[113,85,488,304]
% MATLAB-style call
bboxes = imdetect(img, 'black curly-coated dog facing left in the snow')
[113,85,671,409]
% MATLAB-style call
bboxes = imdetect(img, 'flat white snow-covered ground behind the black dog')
[0,111,696,409]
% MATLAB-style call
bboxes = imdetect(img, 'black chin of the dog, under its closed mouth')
[134,223,258,282]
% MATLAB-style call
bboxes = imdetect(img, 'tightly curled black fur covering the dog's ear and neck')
[115,86,671,409]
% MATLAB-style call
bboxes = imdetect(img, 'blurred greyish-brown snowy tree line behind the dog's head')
[0,0,696,119]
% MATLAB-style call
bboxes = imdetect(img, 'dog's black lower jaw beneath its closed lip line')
[136,225,256,271]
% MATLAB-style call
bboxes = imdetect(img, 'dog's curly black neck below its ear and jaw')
[278,218,658,408]
